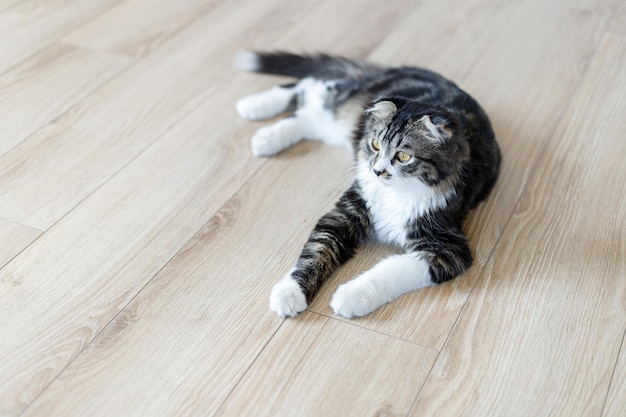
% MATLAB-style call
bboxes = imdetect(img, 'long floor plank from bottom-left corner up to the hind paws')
[0,78,262,415]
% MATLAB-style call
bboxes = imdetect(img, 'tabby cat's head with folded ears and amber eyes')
[358,98,469,191]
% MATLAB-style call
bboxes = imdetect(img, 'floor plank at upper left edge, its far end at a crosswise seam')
[0,44,130,155]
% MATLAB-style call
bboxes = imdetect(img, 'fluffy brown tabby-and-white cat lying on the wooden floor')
[236,51,501,318]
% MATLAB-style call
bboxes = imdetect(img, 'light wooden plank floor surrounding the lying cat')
[0,0,626,417]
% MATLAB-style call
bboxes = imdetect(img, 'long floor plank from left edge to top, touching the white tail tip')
[0,0,316,230]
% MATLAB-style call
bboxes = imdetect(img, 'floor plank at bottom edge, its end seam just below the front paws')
[216,313,437,417]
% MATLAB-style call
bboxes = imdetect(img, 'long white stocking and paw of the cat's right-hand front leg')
[330,252,433,318]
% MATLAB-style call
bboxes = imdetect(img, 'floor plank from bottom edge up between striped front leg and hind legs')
[17,144,349,416]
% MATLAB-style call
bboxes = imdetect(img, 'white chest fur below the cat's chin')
[357,162,446,246]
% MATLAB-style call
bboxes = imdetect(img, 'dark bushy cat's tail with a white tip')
[236,51,378,79]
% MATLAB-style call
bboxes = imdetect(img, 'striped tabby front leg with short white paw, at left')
[270,185,369,317]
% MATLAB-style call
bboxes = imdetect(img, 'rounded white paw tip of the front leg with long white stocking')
[330,280,384,318]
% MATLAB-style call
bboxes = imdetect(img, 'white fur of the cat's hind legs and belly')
[237,78,356,156]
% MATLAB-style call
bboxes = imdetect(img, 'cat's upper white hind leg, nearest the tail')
[236,84,298,120]
